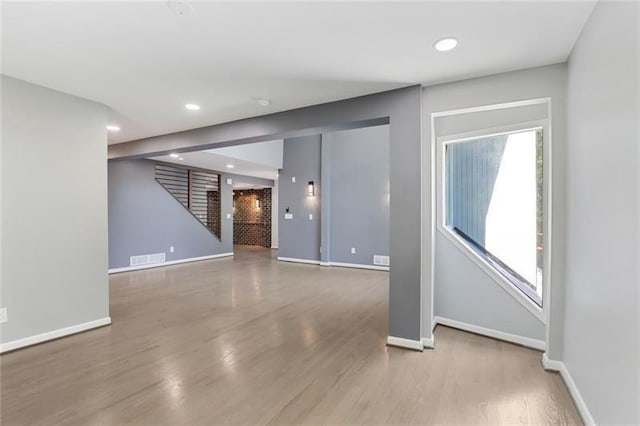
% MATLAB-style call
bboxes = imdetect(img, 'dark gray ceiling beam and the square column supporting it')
[109,86,424,340]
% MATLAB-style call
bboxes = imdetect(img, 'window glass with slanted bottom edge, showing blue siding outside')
[444,129,543,306]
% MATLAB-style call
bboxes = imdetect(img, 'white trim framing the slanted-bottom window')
[431,98,553,326]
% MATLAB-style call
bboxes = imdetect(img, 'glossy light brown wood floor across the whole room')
[0,248,580,425]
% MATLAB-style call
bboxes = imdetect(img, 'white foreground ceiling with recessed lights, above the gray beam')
[2,1,595,143]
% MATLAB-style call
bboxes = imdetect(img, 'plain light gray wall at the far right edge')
[564,2,640,424]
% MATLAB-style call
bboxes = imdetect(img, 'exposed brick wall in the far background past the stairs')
[233,188,271,247]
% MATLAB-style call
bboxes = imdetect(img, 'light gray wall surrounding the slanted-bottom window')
[423,65,566,350]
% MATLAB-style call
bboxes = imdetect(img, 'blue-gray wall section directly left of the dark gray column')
[322,125,390,265]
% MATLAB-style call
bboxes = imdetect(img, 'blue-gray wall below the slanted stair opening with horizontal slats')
[109,160,233,269]
